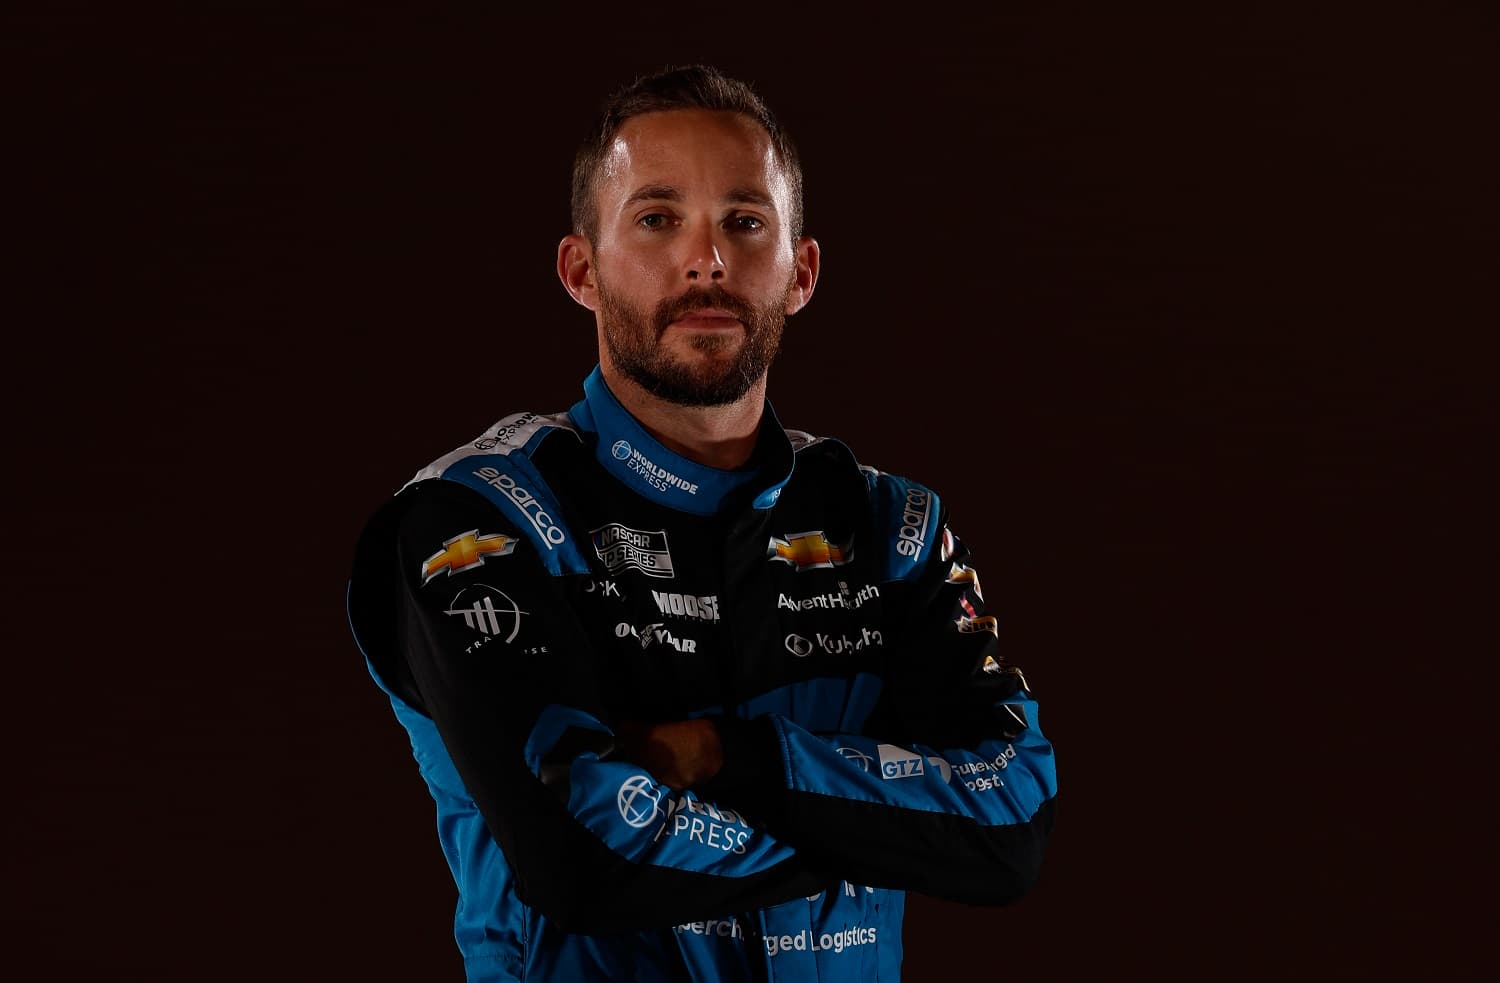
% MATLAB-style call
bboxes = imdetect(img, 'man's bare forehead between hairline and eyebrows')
[599,110,789,210]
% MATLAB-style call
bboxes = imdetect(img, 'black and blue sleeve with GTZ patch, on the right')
[704,501,1058,905]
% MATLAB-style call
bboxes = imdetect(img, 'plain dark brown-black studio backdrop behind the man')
[0,5,1500,980]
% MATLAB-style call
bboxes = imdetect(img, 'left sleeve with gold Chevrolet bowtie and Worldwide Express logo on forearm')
[372,482,833,933]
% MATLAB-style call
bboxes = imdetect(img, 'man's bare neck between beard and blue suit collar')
[600,359,765,471]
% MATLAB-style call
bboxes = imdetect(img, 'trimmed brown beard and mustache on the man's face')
[597,278,795,407]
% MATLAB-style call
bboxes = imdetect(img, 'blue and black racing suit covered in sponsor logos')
[348,368,1056,981]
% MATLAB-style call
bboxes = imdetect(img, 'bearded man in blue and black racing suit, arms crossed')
[350,68,1056,980]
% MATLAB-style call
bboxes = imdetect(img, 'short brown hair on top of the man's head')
[573,65,803,243]
